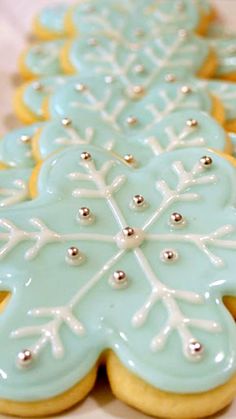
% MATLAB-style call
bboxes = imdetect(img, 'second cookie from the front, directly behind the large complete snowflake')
[6,110,229,166]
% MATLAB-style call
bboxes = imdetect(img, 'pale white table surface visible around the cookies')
[0,0,236,419]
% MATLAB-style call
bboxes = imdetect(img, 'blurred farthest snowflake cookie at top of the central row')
[65,0,212,42]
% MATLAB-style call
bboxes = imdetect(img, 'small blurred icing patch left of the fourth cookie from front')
[24,40,64,76]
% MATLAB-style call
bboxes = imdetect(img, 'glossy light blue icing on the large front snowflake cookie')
[0,146,236,401]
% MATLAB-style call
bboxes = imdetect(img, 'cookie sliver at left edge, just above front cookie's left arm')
[0,169,32,208]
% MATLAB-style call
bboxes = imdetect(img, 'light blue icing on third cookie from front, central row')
[49,76,212,127]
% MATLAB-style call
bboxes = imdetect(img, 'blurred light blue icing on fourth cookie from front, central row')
[67,30,208,83]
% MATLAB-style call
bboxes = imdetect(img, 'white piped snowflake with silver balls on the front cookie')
[0,147,236,370]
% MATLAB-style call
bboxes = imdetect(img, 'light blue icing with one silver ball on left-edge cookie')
[0,123,40,167]
